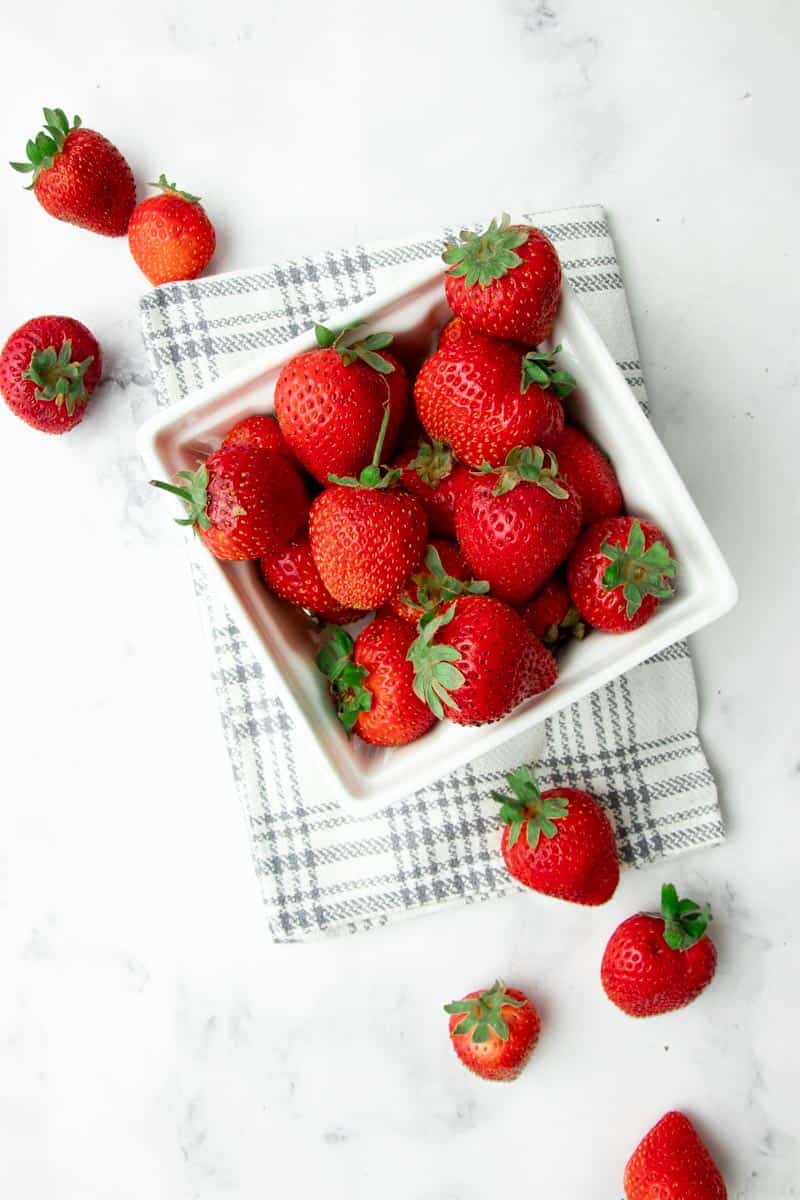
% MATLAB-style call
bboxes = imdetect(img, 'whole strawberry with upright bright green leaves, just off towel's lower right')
[600,883,717,1016]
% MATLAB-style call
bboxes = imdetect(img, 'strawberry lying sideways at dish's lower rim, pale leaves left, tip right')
[409,595,558,725]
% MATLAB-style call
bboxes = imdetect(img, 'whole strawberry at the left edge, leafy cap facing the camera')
[0,317,103,433]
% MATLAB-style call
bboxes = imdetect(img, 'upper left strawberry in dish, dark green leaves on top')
[275,325,408,484]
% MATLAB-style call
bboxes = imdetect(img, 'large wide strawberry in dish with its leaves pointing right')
[414,334,575,467]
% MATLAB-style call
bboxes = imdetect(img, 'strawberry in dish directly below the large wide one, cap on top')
[456,446,581,604]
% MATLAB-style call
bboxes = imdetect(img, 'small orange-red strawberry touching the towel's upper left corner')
[128,175,217,284]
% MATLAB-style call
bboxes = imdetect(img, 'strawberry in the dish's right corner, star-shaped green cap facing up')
[566,517,676,634]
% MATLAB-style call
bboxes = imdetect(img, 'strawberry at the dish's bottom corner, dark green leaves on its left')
[315,613,437,746]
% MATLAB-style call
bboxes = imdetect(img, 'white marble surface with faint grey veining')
[0,0,800,1200]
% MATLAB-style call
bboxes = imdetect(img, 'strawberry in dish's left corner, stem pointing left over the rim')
[150,445,308,562]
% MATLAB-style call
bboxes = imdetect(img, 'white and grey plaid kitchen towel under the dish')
[142,206,723,942]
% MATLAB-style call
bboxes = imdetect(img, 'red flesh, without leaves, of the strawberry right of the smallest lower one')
[600,913,717,1016]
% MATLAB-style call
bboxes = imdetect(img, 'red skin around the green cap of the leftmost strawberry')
[0,316,103,433]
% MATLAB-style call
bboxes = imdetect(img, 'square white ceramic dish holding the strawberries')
[138,258,736,811]
